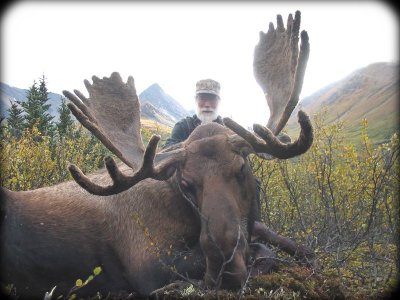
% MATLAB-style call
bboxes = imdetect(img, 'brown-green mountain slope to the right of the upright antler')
[287,62,399,143]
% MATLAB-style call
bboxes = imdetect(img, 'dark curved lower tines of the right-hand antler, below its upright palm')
[224,110,314,159]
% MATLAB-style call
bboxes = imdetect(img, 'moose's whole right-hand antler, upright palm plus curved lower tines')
[224,11,313,158]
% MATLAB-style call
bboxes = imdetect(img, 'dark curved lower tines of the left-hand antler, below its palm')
[69,135,185,196]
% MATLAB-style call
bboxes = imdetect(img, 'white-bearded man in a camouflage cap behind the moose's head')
[164,79,223,148]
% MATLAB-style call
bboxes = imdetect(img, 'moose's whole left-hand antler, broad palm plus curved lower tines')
[63,73,184,196]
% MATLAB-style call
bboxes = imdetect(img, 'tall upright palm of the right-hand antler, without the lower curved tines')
[253,11,310,135]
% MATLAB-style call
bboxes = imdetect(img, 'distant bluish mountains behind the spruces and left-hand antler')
[0,83,190,127]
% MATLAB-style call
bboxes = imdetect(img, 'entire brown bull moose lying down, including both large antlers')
[1,11,313,299]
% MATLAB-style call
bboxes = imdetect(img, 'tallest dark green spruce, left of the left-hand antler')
[18,75,54,136]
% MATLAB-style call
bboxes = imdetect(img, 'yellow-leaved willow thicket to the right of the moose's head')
[251,114,399,293]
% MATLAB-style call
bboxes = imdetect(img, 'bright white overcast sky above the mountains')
[1,1,399,126]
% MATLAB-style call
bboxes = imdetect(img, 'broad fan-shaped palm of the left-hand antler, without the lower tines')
[63,72,144,169]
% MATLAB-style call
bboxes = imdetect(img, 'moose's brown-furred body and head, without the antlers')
[1,124,255,298]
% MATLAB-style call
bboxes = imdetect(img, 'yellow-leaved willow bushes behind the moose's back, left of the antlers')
[0,126,109,191]
